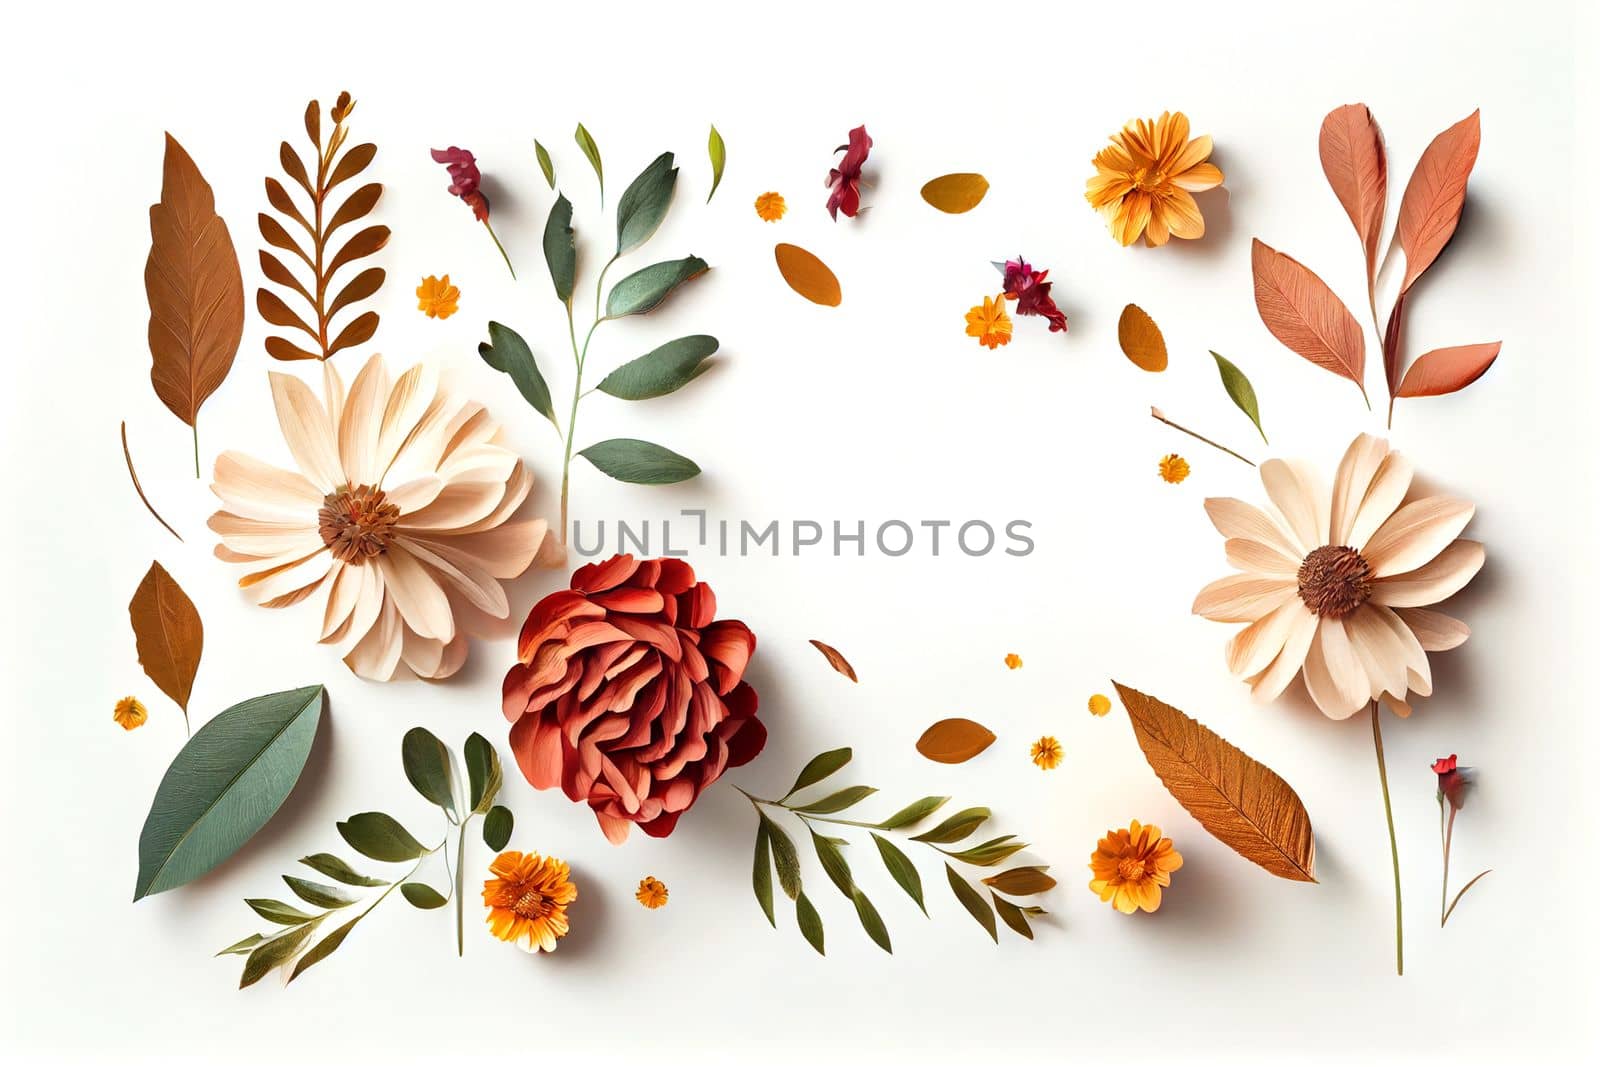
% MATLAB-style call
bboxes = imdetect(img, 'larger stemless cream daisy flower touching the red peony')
[208,355,546,681]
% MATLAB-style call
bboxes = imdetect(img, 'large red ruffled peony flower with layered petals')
[502,555,766,845]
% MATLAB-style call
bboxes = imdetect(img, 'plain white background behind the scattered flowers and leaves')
[0,0,1597,1064]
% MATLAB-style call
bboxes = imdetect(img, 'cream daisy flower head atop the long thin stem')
[1194,434,1483,718]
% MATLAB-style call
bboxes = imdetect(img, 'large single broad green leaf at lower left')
[133,685,323,901]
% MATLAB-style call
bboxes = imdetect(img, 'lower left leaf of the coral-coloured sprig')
[1250,240,1366,397]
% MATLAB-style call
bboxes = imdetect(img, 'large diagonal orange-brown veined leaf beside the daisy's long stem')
[1112,681,1317,881]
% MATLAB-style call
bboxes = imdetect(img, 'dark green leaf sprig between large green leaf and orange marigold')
[218,726,512,989]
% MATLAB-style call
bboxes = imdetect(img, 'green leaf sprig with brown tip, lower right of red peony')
[739,749,1056,955]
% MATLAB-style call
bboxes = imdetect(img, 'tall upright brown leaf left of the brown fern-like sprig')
[144,134,245,427]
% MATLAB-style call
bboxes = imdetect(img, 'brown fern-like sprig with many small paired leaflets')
[256,93,389,360]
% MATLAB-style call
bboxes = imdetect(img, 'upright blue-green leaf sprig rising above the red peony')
[478,126,718,544]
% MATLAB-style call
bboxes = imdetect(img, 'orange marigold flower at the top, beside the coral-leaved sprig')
[1083,112,1222,246]
